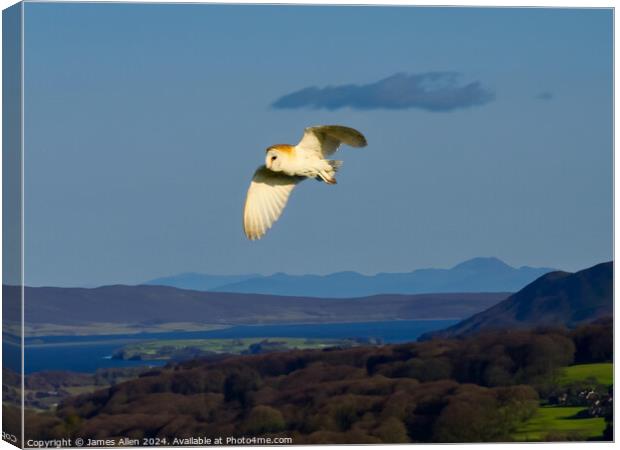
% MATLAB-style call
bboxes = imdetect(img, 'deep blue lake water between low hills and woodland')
[3,320,458,373]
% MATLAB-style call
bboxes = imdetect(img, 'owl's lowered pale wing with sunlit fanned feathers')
[243,166,303,240]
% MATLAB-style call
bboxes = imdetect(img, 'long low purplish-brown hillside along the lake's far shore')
[3,286,508,334]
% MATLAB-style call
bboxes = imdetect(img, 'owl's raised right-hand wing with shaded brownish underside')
[296,125,366,158]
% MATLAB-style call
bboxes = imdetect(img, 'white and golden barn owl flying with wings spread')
[243,125,366,240]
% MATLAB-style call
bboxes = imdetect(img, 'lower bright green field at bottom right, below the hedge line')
[513,406,605,441]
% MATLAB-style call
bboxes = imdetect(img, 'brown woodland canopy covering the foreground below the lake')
[17,319,612,444]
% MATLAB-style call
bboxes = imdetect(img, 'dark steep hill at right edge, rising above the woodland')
[421,262,613,340]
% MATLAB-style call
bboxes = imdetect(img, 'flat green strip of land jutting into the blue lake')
[116,337,355,360]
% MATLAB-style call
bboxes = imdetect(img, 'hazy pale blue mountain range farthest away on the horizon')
[145,258,554,298]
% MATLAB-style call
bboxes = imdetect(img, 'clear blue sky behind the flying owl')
[25,3,613,286]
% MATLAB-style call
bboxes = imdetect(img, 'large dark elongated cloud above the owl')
[272,72,495,112]
